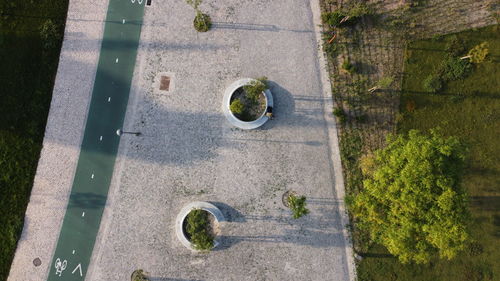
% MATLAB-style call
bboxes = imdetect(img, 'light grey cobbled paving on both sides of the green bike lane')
[9,0,354,281]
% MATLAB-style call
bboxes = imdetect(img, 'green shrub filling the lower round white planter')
[182,209,215,251]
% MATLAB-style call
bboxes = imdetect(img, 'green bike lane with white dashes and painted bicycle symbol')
[47,0,144,281]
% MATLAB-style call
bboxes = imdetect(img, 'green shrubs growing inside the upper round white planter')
[229,77,268,122]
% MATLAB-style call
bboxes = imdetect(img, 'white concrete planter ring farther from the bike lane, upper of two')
[222,78,273,130]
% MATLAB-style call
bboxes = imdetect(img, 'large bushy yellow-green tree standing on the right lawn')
[351,130,469,263]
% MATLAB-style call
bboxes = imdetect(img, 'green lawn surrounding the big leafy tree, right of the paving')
[358,25,500,281]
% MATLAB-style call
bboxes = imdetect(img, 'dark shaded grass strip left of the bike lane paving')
[0,0,68,280]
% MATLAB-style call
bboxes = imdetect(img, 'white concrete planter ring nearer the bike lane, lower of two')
[175,202,226,252]
